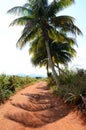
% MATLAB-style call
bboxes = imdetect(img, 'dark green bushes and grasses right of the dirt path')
[48,69,86,110]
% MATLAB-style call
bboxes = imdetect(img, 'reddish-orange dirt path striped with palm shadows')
[0,81,86,130]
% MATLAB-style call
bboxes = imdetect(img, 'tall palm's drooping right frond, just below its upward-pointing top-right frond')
[51,16,82,35]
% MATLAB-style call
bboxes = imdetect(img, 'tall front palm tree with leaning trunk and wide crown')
[8,0,81,84]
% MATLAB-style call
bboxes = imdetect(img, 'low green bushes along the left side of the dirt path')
[0,74,36,104]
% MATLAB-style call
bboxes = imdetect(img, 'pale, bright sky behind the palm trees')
[0,0,86,75]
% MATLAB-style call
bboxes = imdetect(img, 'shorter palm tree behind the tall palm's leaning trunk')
[29,36,76,74]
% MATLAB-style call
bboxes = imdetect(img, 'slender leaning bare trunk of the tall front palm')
[45,40,58,86]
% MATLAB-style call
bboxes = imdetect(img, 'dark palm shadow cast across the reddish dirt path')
[6,87,71,128]
